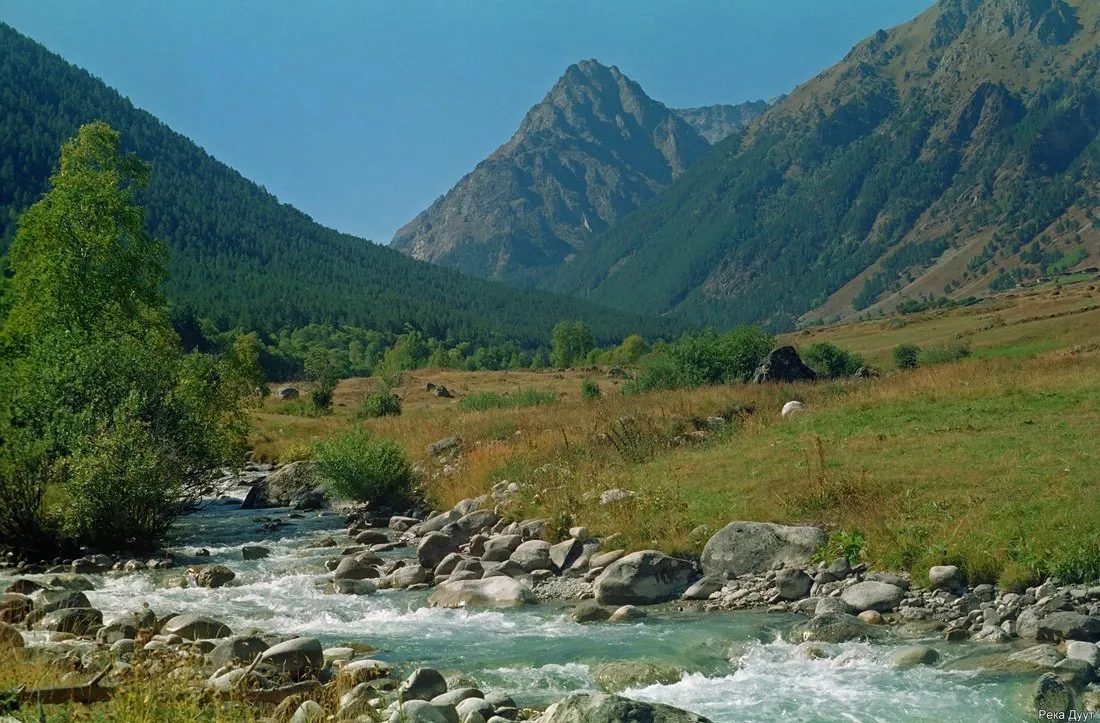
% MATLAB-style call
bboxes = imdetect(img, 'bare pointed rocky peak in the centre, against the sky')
[392,61,707,285]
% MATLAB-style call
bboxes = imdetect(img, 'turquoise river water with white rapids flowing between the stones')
[4,512,1027,723]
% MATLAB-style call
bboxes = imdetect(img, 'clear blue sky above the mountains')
[0,0,932,243]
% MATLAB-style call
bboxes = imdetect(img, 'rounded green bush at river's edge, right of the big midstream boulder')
[314,427,413,503]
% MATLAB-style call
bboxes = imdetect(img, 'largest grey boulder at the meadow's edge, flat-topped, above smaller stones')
[702,522,826,578]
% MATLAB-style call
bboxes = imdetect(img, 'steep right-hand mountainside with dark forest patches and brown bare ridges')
[549,0,1100,328]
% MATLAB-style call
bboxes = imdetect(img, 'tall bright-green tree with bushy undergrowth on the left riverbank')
[0,122,257,551]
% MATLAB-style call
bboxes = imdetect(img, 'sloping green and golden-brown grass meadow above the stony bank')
[256,276,1100,584]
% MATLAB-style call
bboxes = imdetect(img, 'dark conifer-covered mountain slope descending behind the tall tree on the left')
[0,24,674,346]
